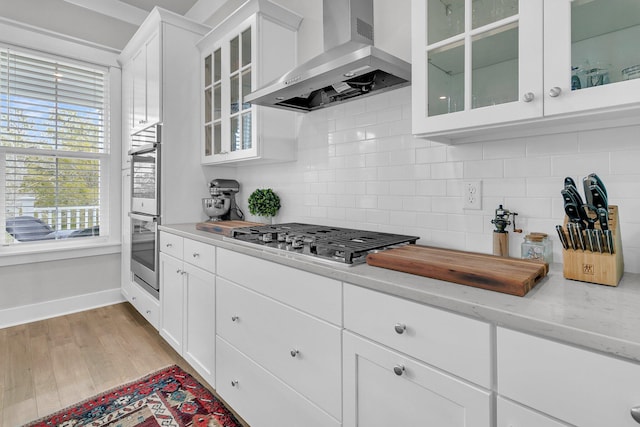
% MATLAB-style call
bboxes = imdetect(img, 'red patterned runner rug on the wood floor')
[27,365,241,427]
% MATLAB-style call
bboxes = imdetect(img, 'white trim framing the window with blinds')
[0,17,122,267]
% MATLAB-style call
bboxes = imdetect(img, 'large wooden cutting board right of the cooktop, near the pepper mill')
[367,245,549,297]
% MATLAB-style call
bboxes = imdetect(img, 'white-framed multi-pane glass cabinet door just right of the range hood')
[412,0,542,133]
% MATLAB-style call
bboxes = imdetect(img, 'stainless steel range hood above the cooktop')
[245,0,411,112]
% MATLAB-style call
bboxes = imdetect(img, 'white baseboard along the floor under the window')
[0,288,125,328]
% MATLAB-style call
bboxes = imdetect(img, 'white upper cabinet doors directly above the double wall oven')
[131,31,162,130]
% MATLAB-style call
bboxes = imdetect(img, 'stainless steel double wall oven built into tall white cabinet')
[129,125,162,298]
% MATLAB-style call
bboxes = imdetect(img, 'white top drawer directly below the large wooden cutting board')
[344,284,491,388]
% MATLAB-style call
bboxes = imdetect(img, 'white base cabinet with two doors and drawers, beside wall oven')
[160,232,216,386]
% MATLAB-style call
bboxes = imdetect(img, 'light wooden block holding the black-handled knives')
[562,206,624,286]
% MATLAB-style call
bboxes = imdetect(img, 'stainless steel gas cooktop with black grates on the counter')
[231,223,418,265]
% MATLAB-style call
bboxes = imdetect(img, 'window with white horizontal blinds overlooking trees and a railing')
[0,47,109,245]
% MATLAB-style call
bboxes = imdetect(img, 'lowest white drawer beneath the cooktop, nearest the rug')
[216,337,340,427]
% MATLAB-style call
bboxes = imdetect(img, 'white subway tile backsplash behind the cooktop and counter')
[232,88,640,272]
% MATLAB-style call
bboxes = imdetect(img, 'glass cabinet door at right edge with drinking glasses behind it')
[544,0,640,114]
